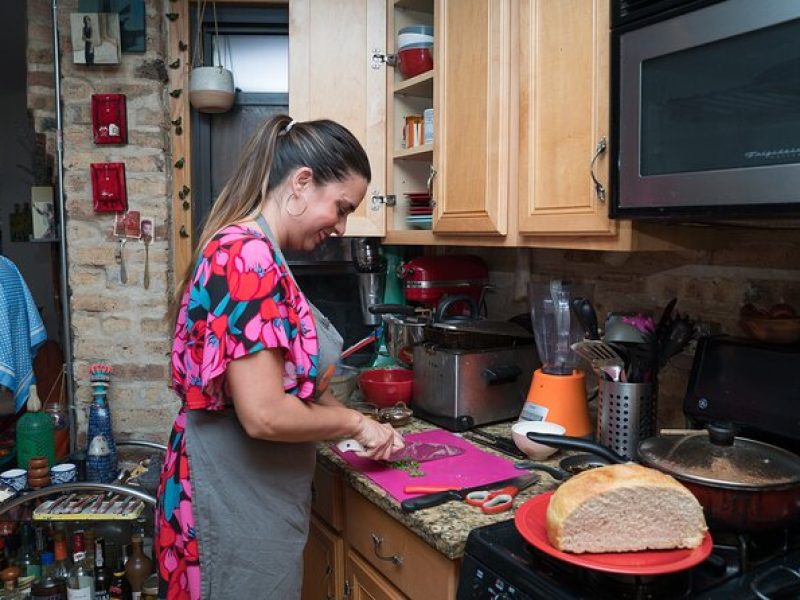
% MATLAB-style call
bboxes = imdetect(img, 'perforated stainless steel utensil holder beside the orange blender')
[597,380,658,460]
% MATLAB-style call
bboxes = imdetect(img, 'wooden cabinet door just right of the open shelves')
[434,0,512,235]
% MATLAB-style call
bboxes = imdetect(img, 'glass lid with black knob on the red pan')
[639,430,800,489]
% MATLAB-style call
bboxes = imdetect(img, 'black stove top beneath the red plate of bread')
[457,519,800,600]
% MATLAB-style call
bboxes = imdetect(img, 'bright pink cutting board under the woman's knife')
[331,429,525,501]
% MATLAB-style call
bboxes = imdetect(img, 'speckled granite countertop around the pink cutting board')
[317,419,564,559]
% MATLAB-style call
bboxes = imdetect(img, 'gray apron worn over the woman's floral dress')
[185,217,342,600]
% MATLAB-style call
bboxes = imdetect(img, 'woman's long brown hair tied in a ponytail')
[175,115,372,309]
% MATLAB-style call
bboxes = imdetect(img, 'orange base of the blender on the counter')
[523,369,592,437]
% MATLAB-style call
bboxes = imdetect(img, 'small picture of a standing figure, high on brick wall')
[70,13,120,65]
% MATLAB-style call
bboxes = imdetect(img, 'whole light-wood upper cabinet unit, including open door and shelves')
[289,0,676,250]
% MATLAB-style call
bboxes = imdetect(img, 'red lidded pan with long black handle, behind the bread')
[528,424,800,533]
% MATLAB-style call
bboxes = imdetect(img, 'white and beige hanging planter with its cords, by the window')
[189,1,236,113]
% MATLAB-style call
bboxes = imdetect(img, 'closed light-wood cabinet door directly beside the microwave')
[518,0,617,235]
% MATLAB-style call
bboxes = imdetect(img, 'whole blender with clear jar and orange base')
[520,279,592,437]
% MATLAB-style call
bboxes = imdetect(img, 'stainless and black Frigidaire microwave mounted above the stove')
[610,0,800,218]
